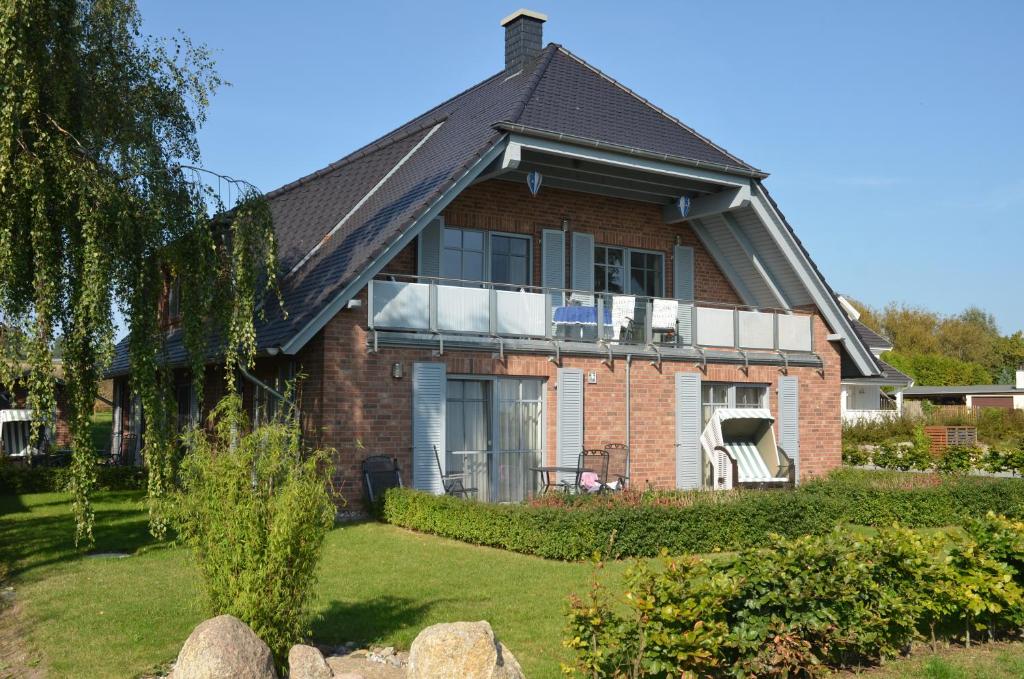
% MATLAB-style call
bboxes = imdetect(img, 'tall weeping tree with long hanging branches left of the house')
[0,0,275,544]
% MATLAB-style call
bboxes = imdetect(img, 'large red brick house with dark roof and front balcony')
[111,10,883,501]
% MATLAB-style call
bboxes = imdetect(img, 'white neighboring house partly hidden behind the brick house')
[839,296,913,423]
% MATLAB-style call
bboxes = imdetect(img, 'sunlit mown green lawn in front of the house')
[0,493,623,679]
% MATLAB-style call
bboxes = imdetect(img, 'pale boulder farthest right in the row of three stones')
[407,621,523,679]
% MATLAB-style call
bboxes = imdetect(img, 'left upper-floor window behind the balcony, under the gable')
[441,227,531,286]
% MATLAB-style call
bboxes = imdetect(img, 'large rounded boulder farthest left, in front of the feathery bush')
[171,616,278,679]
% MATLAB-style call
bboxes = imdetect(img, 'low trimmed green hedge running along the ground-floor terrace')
[381,470,1024,561]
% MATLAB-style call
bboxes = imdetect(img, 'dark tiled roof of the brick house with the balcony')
[110,44,782,374]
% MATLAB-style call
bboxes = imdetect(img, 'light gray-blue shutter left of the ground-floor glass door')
[413,364,447,495]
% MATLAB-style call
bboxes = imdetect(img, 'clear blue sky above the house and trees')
[139,0,1024,332]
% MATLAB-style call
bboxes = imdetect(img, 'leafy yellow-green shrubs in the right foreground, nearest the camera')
[564,514,1024,678]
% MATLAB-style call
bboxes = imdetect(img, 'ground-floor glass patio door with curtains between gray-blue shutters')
[445,377,544,502]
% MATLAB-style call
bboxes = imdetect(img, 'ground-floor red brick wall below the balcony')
[302,292,841,502]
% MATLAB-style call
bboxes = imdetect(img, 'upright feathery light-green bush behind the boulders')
[171,396,335,663]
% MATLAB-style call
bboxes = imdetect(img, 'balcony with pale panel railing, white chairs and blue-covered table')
[368,274,821,366]
